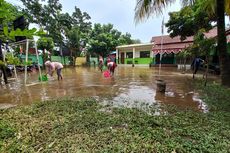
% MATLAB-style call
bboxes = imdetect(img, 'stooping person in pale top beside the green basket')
[45,61,63,80]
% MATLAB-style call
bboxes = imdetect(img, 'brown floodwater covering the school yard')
[0,66,212,112]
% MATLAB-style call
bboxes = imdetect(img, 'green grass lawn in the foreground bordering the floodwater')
[0,80,230,153]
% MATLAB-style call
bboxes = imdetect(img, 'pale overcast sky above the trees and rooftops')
[6,0,183,43]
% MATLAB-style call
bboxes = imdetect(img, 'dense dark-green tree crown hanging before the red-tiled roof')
[166,1,214,40]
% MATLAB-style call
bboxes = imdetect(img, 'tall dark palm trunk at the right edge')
[216,0,230,87]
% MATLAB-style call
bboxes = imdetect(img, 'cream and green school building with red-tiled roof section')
[116,28,230,66]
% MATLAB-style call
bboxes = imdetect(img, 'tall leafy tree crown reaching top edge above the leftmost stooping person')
[21,0,66,45]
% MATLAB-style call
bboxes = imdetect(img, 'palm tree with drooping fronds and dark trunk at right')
[135,0,230,87]
